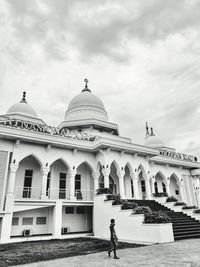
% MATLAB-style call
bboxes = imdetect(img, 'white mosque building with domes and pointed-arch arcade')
[0,79,200,243]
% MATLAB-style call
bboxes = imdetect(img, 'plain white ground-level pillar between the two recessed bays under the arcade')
[52,200,62,238]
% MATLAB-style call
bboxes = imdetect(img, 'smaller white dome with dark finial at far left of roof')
[6,92,37,118]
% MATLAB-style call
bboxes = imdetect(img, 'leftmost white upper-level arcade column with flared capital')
[5,164,18,212]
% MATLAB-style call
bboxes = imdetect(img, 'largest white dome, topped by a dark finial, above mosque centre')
[65,79,108,121]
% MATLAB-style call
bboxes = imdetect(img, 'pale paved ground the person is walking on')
[14,239,200,267]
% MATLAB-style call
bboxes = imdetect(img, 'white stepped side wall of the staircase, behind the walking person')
[94,195,174,243]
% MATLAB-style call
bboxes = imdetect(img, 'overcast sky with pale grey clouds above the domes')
[0,0,200,156]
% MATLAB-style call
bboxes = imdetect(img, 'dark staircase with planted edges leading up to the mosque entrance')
[128,199,200,240]
